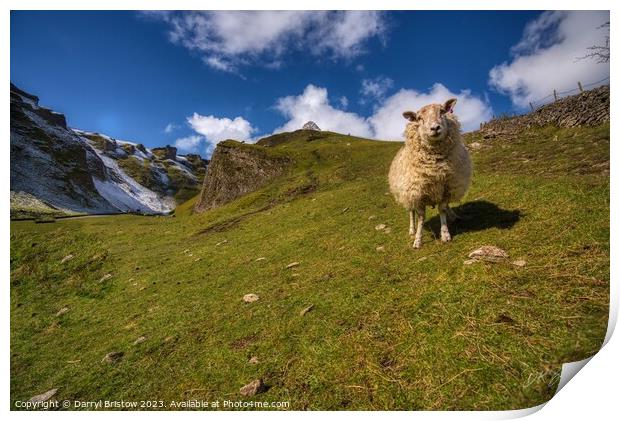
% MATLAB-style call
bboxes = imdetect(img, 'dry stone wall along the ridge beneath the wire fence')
[480,85,609,138]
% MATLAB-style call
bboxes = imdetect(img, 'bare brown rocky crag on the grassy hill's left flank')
[194,140,291,213]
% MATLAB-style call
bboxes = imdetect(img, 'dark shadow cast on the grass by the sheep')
[425,200,523,238]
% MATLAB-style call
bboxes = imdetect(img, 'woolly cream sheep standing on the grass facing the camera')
[388,98,472,249]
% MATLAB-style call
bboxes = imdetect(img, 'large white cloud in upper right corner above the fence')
[489,11,609,108]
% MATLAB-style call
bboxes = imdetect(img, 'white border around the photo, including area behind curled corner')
[0,0,620,420]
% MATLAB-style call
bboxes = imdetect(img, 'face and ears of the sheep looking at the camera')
[403,98,456,144]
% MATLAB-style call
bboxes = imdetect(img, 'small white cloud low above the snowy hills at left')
[187,113,257,144]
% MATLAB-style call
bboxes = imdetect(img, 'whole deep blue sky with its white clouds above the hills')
[11,11,609,156]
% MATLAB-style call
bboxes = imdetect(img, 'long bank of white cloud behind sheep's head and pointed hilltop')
[274,83,492,140]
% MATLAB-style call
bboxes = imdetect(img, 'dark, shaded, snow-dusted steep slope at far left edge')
[10,84,116,212]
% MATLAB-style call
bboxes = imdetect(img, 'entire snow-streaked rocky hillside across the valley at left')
[10,84,206,217]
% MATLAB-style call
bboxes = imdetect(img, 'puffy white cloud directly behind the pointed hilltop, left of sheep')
[274,85,372,137]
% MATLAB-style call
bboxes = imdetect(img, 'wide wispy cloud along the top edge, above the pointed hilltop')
[144,11,386,72]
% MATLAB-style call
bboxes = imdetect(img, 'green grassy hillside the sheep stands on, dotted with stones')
[11,125,609,409]
